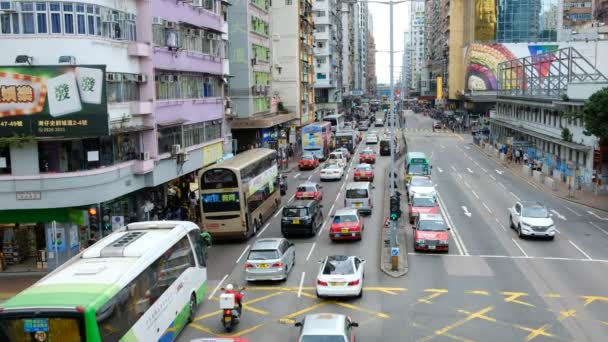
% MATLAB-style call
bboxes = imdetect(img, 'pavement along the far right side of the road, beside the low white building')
[473,144,608,212]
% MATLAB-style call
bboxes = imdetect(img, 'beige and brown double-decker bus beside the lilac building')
[198,148,281,239]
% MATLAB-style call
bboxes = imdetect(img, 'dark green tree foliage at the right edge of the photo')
[583,87,608,140]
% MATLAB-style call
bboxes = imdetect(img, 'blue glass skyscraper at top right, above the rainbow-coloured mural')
[496,0,559,43]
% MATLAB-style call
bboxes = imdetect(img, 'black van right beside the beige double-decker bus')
[281,200,323,236]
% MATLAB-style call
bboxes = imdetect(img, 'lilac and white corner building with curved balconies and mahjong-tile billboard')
[0,0,230,271]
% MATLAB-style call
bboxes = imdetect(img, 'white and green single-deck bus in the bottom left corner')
[0,221,211,342]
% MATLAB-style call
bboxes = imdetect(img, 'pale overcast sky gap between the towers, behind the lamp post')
[368,2,410,83]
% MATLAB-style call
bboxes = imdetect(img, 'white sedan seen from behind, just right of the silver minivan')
[317,255,365,298]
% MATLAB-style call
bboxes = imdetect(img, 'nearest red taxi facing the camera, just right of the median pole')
[413,214,450,252]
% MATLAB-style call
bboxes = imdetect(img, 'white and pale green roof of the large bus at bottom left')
[0,221,198,309]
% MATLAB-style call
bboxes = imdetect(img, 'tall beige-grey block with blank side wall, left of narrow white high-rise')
[271,0,315,126]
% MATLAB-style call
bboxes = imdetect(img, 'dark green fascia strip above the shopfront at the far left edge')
[0,208,85,224]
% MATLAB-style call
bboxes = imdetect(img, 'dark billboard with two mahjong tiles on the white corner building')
[0,65,109,137]
